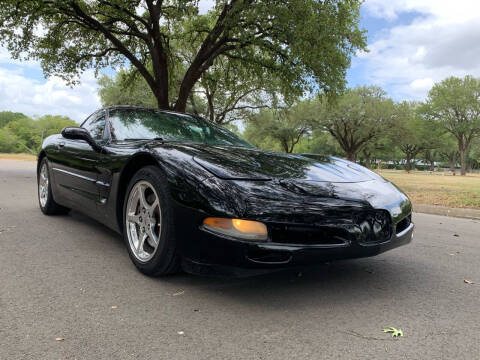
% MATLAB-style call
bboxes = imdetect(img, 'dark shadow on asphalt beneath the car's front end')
[156,254,433,310]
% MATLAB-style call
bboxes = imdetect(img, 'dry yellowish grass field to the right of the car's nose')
[379,170,480,209]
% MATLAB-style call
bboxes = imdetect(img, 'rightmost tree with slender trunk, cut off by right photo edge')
[425,76,480,176]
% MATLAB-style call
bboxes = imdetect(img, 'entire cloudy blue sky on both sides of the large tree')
[0,0,480,122]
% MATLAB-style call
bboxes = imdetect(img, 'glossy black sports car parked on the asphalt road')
[37,106,414,276]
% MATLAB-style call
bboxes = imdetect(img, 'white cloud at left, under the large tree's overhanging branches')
[0,64,101,122]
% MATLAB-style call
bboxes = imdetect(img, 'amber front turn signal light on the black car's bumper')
[203,218,268,240]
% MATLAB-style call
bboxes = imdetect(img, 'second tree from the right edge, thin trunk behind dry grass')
[391,101,441,171]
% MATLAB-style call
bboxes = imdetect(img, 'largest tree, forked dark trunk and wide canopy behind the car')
[0,0,366,111]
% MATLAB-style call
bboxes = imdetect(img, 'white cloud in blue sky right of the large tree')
[358,0,480,99]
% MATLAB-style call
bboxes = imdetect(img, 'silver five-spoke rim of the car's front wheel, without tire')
[125,181,162,262]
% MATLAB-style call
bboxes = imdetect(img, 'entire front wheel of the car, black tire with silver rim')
[123,166,180,276]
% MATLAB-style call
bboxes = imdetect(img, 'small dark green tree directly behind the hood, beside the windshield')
[244,100,318,154]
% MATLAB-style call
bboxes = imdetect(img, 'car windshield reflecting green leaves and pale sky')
[110,109,253,147]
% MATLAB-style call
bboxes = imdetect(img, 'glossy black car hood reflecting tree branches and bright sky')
[184,145,381,183]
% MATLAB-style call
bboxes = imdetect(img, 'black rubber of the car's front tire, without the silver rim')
[122,166,176,275]
